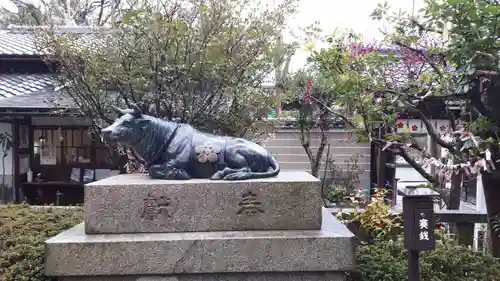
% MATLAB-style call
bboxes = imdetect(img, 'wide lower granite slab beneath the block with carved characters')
[45,209,355,276]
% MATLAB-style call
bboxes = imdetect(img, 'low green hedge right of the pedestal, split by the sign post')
[348,238,500,281]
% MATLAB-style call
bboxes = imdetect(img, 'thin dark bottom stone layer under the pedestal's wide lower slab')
[59,272,345,281]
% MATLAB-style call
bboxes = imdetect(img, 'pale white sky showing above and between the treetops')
[0,0,424,71]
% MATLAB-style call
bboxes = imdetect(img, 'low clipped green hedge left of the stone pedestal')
[0,205,83,281]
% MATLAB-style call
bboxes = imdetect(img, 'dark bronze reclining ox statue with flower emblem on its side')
[101,104,280,180]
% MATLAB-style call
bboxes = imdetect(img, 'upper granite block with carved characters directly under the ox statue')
[85,172,322,234]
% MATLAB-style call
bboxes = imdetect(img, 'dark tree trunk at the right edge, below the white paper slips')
[482,170,500,258]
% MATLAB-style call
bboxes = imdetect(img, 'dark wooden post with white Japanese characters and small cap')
[398,186,439,281]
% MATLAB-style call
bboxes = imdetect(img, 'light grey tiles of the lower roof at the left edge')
[0,74,53,99]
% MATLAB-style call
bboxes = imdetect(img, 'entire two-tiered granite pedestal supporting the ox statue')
[45,172,355,281]
